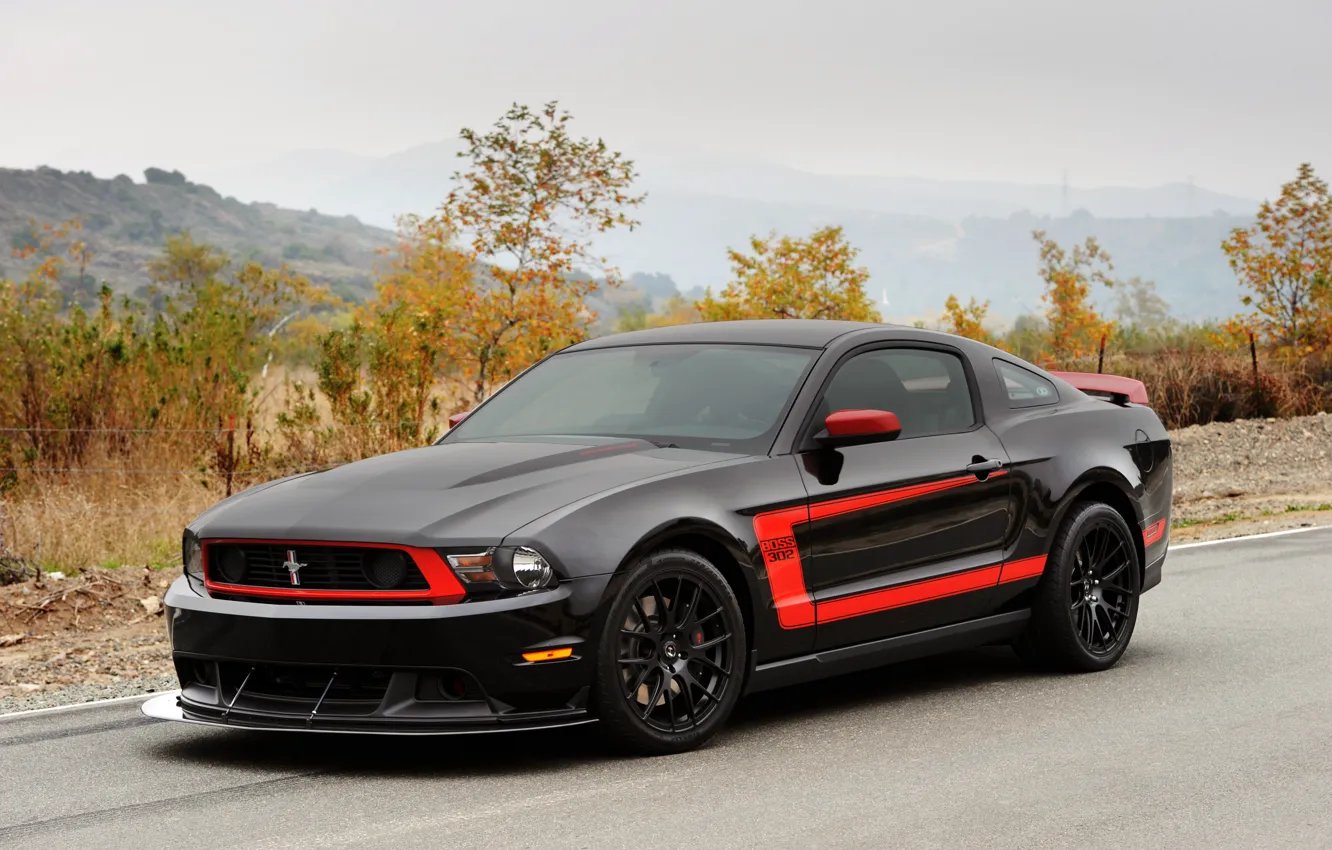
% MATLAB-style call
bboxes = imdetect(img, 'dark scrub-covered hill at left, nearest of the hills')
[0,168,393,300]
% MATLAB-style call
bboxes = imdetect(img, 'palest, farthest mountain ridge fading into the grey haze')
[202,140,1257,228]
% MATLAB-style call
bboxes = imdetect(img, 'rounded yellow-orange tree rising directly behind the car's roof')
[698,226,879,321]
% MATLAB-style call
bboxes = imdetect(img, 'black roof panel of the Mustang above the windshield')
[565,318,902,350]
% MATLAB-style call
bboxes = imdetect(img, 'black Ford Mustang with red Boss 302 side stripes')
[145,321,1171,753]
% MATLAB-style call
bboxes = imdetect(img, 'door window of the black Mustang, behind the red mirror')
[821,348,976,440]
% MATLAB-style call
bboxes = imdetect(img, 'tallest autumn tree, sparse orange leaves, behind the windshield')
[420,101,645,402]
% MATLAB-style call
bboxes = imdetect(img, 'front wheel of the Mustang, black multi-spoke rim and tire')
[591,549,749,755]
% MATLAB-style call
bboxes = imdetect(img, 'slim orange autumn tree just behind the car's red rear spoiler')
[1031,230,1115,365]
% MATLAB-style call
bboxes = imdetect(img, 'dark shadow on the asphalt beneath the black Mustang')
[143,647,1092,778]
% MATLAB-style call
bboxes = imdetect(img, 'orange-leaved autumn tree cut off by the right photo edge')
[1221,163,1332,350]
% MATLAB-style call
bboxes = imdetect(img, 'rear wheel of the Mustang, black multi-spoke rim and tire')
[1014,502,1142,673]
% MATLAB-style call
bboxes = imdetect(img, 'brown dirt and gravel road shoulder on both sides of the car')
[0,414,1332,714]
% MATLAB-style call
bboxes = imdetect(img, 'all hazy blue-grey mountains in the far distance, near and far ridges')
[199,141,1257,321]
